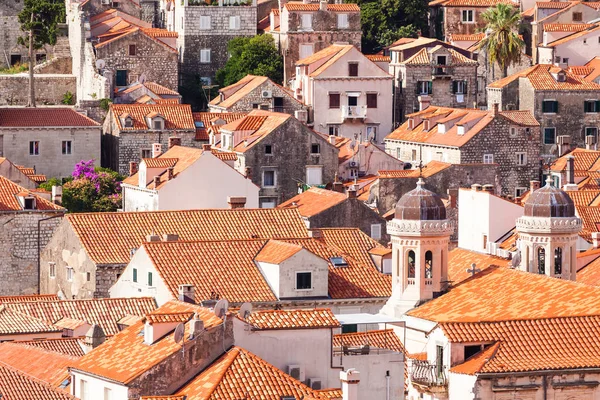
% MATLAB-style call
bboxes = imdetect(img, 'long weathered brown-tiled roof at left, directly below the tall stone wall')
[4,297,156,335]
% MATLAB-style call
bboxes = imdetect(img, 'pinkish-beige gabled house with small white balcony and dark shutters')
[292,44,393,144]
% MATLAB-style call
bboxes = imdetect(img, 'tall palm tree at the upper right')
[479,3,525,78]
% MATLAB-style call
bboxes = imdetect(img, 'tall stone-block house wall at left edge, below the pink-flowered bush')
[0,212,63,296]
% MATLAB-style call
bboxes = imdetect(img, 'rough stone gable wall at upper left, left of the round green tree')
[96,31,178,91]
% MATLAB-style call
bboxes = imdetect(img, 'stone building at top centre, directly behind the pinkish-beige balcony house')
[268,0,362,86]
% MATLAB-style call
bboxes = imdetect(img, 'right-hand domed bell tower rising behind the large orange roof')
[515,177,581,281]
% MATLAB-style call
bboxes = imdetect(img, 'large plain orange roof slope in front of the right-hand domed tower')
[407,266,600,323]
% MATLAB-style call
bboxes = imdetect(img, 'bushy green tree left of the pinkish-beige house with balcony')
[216,35,283,87]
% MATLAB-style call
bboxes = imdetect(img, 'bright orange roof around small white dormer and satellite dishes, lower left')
[73,301,222,384]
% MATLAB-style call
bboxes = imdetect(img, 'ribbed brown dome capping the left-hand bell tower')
[394,179,446,221]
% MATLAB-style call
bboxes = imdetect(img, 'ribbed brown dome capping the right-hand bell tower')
[525,177,575,218]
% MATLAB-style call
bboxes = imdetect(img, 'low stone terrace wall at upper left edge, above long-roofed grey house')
[0,74,77,106]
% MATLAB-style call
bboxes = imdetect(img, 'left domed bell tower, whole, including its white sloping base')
[382,179,454,316]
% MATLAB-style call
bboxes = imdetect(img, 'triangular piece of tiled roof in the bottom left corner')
[0,363,75,400]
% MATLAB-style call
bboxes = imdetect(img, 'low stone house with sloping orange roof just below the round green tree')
[208,75,308,122]
